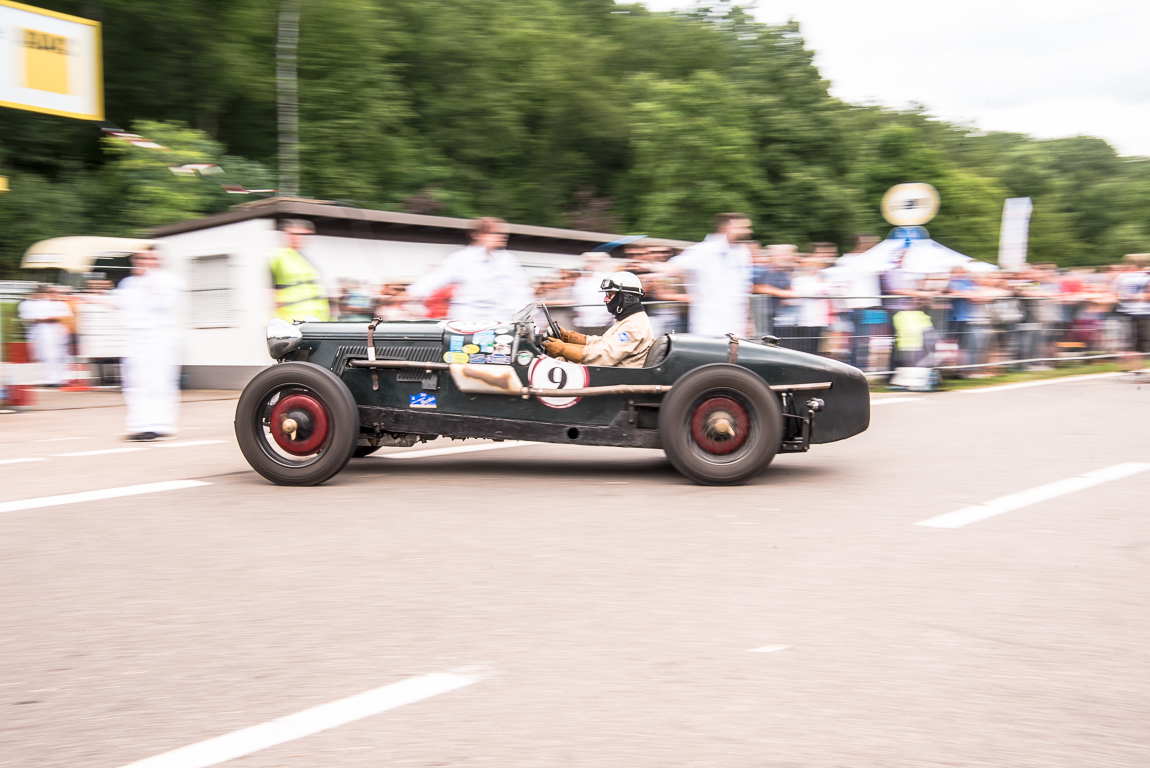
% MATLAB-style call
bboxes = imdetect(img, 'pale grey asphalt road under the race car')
[0,376,1150,768]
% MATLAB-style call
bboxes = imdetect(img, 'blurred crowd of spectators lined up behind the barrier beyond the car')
[324,236,1150,377]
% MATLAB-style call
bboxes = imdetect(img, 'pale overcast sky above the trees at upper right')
[644,0,1150,156]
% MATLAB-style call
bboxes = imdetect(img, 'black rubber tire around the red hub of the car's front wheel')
[236,362,359,485]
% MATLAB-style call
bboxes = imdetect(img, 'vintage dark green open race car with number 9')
[236,304,871,485]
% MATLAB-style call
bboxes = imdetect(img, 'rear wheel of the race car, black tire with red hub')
[659,363,783,485]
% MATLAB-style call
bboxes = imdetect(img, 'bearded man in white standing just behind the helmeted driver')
[667,214,753,336]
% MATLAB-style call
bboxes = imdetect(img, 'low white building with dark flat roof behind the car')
[152,198,689,389]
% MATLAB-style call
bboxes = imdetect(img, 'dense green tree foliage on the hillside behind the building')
[0,0,1150,274]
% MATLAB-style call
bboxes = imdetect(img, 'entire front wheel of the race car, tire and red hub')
[236,362,359,485]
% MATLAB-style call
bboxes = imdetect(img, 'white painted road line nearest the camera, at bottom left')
[115,673,480,768]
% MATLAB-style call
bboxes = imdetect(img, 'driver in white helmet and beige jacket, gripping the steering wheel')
[543,272,654,368]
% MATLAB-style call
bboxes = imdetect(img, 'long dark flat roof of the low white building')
[151,198,691,253]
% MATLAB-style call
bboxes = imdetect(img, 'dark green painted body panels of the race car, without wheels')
[289,321,871,443]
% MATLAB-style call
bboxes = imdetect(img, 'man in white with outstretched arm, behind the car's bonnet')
[407,217,535,320]
